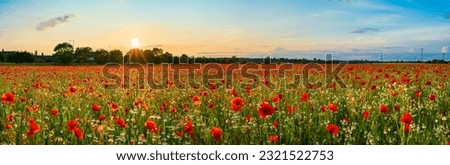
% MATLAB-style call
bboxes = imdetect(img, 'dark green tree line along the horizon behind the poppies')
[0,42,447,65]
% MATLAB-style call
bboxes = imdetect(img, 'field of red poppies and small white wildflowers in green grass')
[0,64,450,145]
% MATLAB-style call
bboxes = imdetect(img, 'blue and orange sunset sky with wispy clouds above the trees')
[0,0,450,60]
